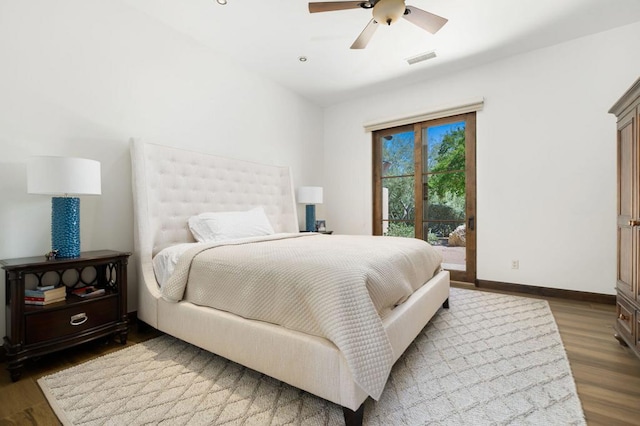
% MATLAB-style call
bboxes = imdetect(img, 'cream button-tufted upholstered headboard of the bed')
[131,140,298,255]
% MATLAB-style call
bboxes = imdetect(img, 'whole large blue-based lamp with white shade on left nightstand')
[27,156,101,258]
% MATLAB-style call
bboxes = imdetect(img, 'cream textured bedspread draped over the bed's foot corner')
[162,234,442,399]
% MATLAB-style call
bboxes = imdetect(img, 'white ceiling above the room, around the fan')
[124,0,640,106]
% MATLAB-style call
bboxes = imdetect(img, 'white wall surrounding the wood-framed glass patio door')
[324,23,640,294]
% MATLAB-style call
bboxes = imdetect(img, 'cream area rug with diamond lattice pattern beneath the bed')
[38,288,586,426]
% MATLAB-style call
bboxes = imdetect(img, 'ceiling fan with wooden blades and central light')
[309,0,447,49]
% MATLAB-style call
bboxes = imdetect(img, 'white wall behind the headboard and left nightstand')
[0,0,323,330]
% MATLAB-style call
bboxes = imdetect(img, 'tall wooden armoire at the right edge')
[609,78,640,356]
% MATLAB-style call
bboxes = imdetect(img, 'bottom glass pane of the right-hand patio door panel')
[423,221,467,271]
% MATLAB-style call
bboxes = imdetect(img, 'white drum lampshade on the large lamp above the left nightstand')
[27,156,102,195]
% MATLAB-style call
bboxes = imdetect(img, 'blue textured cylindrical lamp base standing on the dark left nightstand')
[51,197,80,258]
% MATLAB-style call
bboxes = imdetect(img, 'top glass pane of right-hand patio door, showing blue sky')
[422,121,465,173]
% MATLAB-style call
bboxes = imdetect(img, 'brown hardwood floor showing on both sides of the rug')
[0,286,640,426]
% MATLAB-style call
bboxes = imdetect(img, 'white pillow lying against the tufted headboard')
[189,207,275,243]
